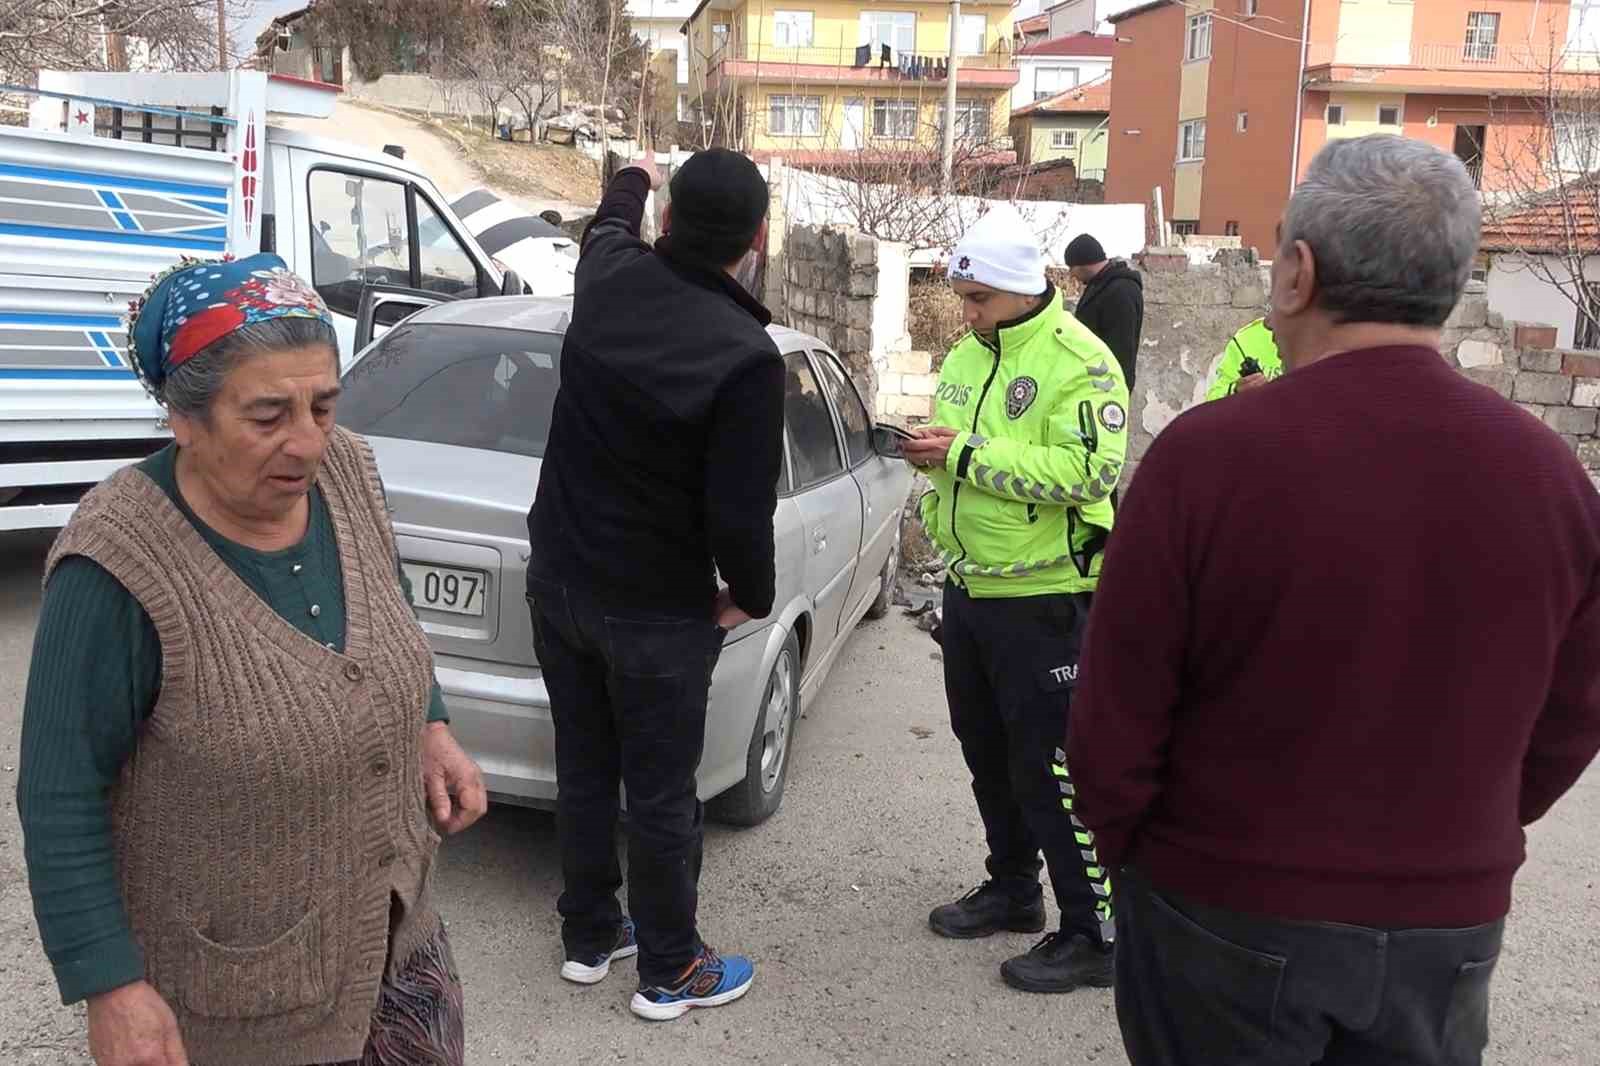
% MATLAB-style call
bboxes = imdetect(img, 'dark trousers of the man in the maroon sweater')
[1117,869,1497,1066]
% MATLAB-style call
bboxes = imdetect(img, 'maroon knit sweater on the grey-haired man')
[1067,347,1600,928]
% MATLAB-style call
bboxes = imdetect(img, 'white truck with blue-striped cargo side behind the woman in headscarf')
[0,70,523,531]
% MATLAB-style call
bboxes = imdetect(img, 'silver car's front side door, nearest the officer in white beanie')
[813,349,906,621]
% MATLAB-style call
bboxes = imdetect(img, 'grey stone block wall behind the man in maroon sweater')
[1126,250,1600,477]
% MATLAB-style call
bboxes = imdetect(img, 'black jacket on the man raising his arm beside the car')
[528,170,784,618]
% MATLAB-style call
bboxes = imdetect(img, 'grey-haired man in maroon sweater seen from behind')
[1067,136,1600,1066]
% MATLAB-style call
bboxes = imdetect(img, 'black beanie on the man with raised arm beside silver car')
[672,149,768,267]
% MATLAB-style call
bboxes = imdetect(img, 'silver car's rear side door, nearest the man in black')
[784,351,861,643]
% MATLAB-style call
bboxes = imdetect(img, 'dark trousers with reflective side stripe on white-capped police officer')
[941,583,1115,943]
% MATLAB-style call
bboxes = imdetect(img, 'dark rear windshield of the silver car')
[339,316,562,458]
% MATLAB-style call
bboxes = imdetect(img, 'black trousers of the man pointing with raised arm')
[528,576,725,984]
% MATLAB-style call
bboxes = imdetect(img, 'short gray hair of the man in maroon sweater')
[1282,134,1483,327]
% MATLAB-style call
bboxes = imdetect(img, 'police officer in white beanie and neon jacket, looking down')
[906,211,1128,992]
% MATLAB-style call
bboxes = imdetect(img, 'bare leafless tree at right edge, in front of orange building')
[1478,34,1600,346]
